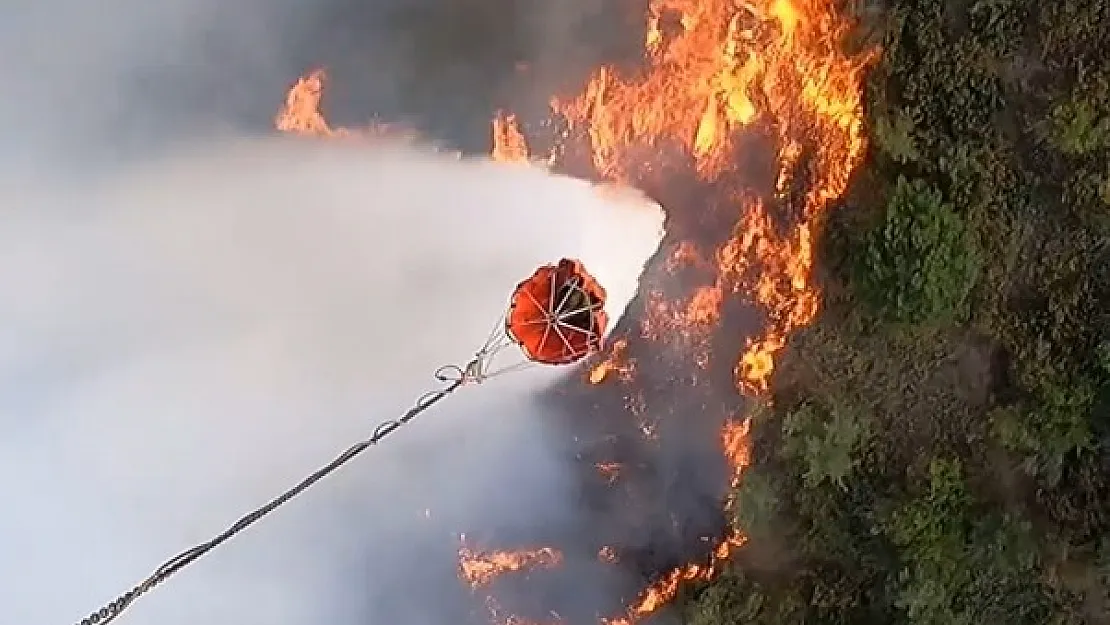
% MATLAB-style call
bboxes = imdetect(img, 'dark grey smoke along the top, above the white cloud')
[0,0,643,158]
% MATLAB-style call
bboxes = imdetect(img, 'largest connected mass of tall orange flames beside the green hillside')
[553,0,874,394]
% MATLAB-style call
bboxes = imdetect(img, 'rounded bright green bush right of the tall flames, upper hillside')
[858,177,980,324]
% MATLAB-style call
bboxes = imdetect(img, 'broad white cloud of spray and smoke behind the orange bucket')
[0,139,662,625]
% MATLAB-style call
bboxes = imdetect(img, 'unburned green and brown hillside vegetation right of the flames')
[682,0,1110,625]
